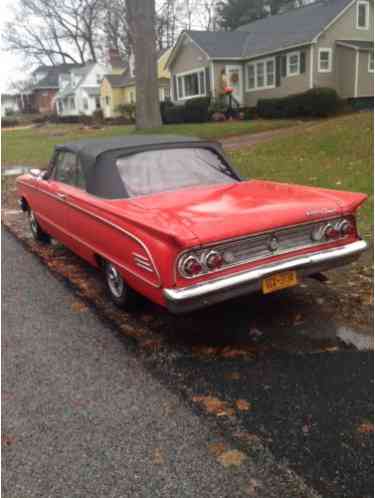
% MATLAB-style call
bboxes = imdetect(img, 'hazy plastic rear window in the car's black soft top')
[116,148,238,197]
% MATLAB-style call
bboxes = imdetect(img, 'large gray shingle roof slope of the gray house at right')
[187,0,351,58]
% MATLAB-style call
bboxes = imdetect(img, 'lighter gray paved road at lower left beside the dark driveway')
[2,233,324,498]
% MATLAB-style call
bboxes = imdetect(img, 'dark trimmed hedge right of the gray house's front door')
[257,88,341,118]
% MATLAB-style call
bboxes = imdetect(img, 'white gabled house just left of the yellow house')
[55,62,108,116]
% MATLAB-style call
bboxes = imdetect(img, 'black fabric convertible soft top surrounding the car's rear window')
[50,135,239,198]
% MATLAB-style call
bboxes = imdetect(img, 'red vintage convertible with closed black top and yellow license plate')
[17,135,367,313]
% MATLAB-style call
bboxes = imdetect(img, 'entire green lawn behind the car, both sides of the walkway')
[2,112,373,237]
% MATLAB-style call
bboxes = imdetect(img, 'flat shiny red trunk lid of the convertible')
[111,180,366,244]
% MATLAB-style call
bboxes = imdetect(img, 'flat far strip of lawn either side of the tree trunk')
[2,119,297,167]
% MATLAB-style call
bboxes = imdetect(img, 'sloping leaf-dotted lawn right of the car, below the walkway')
[230,112,374,237]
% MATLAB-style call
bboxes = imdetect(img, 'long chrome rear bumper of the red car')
[163,240,367,313]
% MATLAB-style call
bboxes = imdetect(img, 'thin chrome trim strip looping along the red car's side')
[19,181,162,288]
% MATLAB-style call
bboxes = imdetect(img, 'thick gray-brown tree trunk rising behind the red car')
[128,0,162,129]
